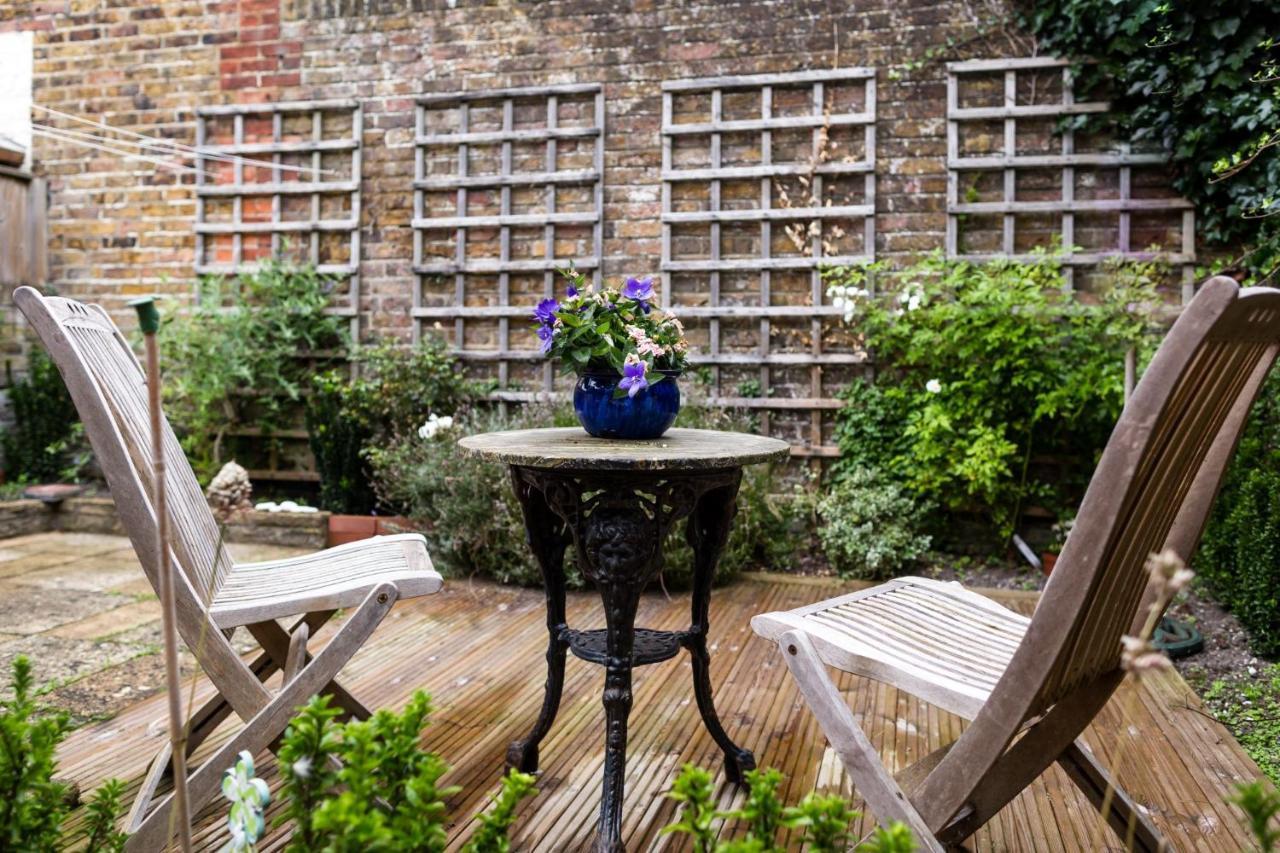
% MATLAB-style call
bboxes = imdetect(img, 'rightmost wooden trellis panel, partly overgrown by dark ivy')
[946,58,1196,298]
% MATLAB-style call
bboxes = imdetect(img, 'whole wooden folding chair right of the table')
[751,277,1280,850]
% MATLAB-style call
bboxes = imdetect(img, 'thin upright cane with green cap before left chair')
[129,296,191,853]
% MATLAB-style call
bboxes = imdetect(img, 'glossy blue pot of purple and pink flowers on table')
[534,269,689,439]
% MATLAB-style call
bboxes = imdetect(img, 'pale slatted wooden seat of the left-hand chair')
[209,533,442,628]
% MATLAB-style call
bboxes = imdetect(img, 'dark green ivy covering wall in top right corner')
[1023,0,1280,278]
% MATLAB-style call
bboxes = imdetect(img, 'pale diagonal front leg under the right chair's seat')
[778,631,945,853]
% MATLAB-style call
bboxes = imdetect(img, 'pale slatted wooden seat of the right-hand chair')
[751,578,1030,720]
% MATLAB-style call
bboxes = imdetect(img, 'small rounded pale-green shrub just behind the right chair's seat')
[818,467,929,580]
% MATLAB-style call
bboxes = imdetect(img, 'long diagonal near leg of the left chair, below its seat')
[125,584,397,853]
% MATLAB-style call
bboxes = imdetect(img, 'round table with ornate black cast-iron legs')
[458,428,790,853]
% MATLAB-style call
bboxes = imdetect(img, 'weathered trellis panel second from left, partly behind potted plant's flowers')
[412,85,604,401]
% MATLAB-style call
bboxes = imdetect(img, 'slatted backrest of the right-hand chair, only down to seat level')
[1010,278,1280,708]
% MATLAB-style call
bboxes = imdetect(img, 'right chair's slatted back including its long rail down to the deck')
[911,277,1280,835]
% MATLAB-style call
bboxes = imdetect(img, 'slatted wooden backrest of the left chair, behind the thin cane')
[14,287,265,707]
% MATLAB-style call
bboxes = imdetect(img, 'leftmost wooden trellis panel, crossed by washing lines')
[196,100,364,338]
